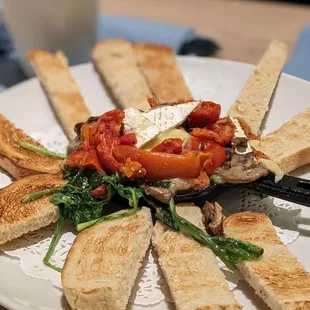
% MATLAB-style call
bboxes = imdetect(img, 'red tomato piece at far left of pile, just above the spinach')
[67,149,103,172]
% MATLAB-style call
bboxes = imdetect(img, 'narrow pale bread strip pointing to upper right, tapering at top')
[228,40,288,134]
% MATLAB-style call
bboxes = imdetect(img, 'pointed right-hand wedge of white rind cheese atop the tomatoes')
[142,101,200,132]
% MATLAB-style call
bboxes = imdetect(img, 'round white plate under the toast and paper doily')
[0,57,310,310]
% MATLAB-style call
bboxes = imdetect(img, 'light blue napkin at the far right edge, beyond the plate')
[284,25,310,81]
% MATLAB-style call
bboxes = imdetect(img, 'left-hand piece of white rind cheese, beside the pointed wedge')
[123,108,161,147]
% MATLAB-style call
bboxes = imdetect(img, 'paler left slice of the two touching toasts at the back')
[92,39,152,111]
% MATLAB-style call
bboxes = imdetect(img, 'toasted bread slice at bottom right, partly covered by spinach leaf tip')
[224,211,310,310]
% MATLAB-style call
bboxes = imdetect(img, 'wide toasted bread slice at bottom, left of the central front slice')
[61,208,153,310]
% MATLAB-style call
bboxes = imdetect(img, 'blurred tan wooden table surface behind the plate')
[100,0,310,63]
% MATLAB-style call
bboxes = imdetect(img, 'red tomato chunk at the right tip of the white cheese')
[188,101,221,128]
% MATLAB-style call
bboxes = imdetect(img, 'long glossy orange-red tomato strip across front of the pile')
[113,145,201,181]
